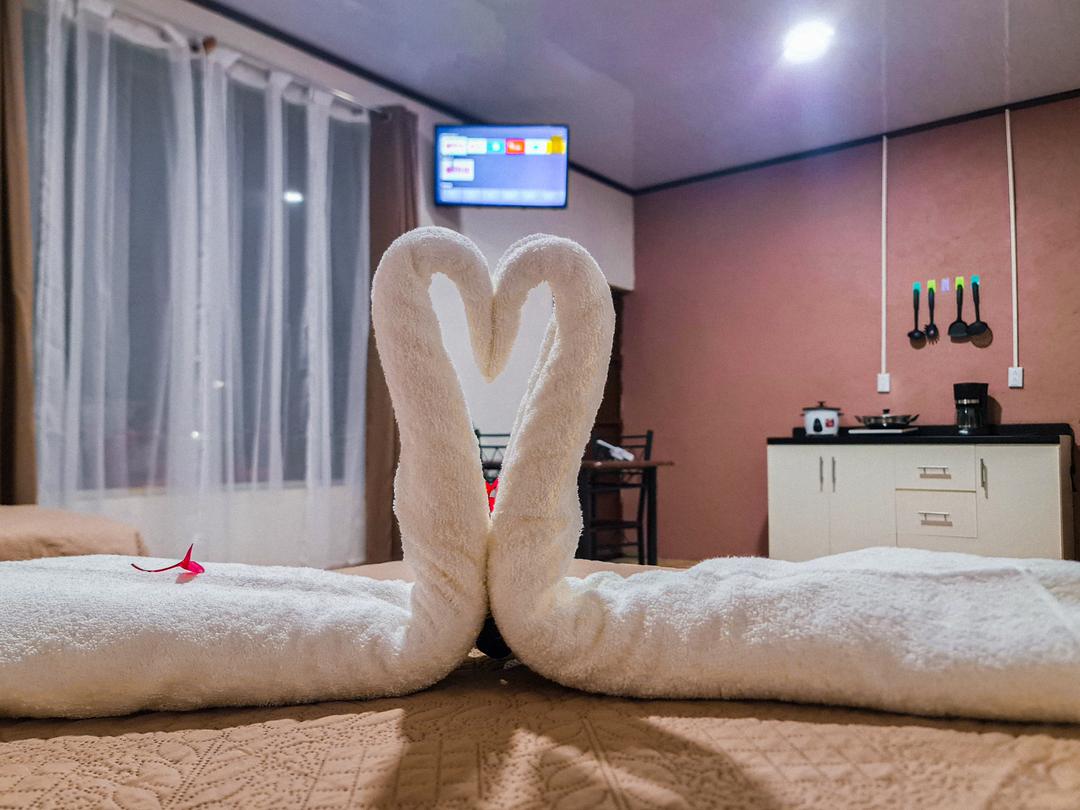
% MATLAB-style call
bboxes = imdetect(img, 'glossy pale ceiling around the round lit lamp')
[214,0,1080,189]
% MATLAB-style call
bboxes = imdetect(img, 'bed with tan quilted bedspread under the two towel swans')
[0,562,1080,808]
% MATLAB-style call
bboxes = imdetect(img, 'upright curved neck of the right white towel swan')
[488,238,615,656]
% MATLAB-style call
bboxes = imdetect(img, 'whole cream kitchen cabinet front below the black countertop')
[768,435,1076,561]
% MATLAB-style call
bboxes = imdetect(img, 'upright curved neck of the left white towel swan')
[372,228,492,680]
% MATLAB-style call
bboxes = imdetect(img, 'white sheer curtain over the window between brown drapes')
[26,0,368,566]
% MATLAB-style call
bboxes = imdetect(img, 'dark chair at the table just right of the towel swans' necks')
[582,430,652,565]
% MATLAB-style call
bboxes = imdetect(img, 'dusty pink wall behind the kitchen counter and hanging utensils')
[623,100,1080,559]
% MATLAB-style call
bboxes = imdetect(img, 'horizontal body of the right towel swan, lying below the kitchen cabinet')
[491,548,1080,723]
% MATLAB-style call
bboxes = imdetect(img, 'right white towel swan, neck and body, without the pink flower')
[488,231,1080,721]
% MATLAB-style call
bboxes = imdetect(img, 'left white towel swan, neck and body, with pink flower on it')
[0,225,494,717]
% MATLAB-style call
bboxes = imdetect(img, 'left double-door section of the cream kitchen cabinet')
[769,445,896,561]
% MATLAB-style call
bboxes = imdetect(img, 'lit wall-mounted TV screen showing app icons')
[435,124,570,208]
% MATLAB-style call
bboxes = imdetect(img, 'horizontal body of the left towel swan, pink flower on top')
[0,555,457,717]
